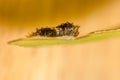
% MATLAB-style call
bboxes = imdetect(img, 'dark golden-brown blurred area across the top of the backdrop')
[0,0,108,26]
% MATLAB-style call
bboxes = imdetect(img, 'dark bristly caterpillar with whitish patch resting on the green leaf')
[27,22,80,37]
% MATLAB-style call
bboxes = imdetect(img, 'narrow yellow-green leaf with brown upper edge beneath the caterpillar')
[8,28,120,47]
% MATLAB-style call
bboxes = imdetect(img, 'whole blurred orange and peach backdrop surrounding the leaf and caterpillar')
[0,0,120,80]
